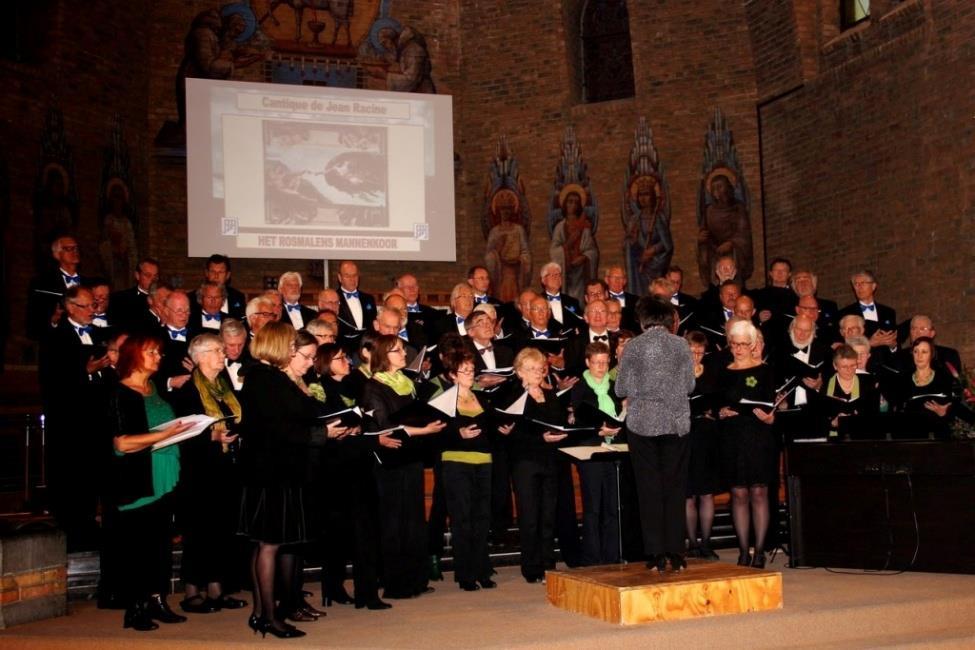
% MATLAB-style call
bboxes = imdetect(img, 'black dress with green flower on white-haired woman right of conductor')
[718,364,778,487]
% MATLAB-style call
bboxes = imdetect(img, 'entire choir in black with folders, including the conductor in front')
[27,237,967,638]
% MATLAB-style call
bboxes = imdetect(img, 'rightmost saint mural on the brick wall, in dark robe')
[697,109,755,286]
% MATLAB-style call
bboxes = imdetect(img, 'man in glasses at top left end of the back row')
[27,236,83,340]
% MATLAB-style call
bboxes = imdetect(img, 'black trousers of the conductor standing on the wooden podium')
[628,435,690,557]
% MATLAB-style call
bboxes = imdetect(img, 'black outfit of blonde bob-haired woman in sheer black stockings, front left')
[238,364,325,544]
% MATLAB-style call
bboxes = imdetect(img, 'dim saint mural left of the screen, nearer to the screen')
[98,113,139,287]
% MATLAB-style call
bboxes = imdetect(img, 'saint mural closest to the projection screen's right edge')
[481,135,532,302]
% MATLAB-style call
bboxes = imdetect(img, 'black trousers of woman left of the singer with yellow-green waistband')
[376,461,429,596]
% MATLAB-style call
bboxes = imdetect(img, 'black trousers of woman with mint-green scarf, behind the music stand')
[578,460,620,566]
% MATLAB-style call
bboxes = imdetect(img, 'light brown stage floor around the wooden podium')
[0,551,975,650]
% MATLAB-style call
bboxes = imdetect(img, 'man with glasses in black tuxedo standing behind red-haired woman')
[38,286,109,551]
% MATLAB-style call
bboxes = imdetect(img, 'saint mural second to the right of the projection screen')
[548,126,599,302]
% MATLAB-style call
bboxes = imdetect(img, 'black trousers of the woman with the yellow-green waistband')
[443,461,491,582]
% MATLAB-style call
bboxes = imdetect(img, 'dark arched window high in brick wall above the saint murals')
[581,0,634,102]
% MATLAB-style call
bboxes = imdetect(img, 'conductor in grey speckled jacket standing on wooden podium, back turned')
[616,296,694,572]
